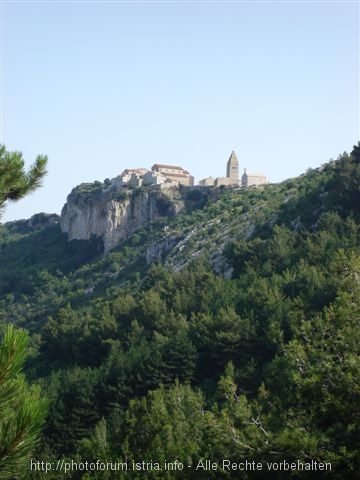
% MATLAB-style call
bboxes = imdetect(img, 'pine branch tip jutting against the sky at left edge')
[0,145,47,214]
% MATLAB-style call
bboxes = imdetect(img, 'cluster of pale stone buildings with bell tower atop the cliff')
[111,151,267,188]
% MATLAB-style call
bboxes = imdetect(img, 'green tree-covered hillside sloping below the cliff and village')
[0,146,360,479]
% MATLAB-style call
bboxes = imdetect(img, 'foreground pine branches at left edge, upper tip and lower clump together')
[0,145,47,479]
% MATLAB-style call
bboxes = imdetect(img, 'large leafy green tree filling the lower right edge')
[262,255,360,480]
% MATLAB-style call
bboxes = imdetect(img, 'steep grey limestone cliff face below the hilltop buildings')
[61,185,184,253]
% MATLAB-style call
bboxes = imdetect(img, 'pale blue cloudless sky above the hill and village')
[0,0,360,221]
